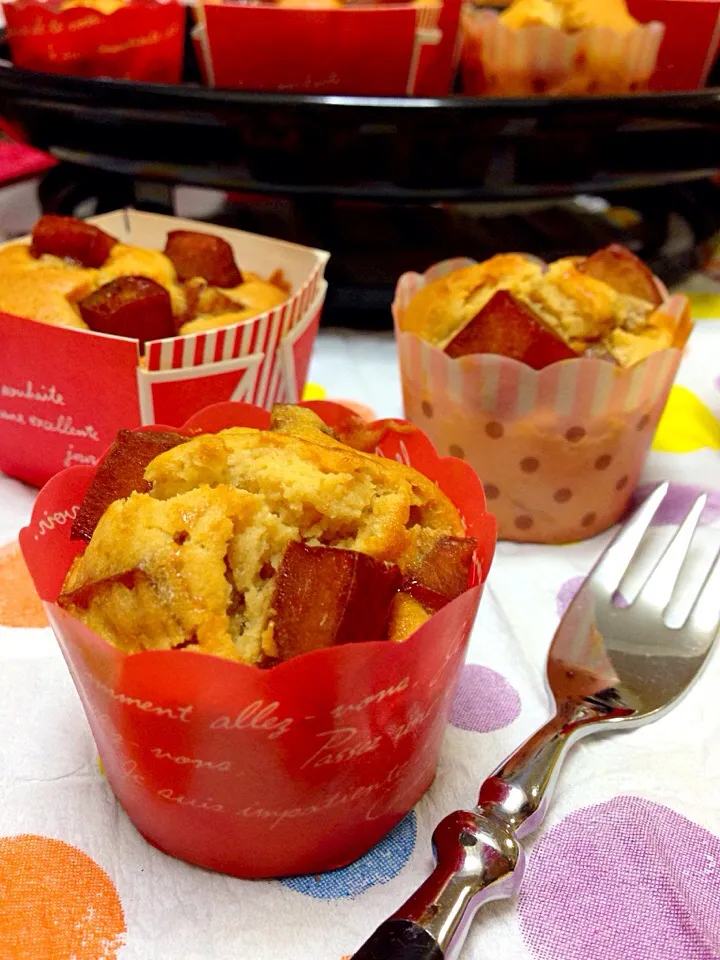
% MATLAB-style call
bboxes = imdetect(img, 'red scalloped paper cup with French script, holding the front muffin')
[20,401,495,877]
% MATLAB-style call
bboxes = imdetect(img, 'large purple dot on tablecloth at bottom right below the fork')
[518,797,720,960]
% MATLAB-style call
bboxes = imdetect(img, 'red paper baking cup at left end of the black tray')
[3,0,185,83]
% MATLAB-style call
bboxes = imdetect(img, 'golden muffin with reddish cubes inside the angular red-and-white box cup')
[0,215,289,346]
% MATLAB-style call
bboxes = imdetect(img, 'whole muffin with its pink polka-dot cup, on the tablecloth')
[393,245,692,543]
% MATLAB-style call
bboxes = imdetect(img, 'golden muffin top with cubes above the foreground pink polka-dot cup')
[400,244,689,369]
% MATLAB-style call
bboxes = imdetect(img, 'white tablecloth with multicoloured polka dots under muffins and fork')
[0,321,720,960]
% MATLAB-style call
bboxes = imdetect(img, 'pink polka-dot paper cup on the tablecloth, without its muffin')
[393,260,690,543]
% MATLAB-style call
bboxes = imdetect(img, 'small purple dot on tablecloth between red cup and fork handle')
[450,663,521,733]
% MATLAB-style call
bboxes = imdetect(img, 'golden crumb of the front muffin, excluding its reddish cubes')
[59,407,474,664]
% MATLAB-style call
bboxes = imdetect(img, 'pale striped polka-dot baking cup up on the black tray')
[462,4,665,97]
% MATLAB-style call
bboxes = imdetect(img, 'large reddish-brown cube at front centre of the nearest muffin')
[273,543,402,660]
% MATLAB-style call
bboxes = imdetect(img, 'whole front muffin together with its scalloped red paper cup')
[20,403,495,877]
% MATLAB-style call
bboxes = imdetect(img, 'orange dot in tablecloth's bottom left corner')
[0,834,125,960]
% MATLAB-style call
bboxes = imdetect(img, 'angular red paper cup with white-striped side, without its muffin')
[0,210,329,486]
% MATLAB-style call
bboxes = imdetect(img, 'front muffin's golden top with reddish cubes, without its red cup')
[58,406,476,666]
